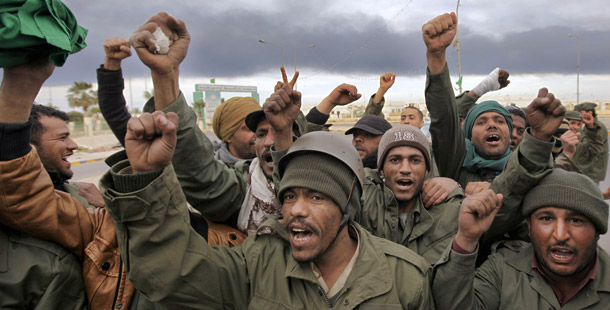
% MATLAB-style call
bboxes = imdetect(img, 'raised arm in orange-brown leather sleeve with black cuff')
[0,60,101,261]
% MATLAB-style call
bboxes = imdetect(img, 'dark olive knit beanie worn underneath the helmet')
[278,152,360,214]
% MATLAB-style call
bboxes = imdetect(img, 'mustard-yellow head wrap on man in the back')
[212,97,261,142]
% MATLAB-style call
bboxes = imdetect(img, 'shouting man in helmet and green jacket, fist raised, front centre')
[102,108,433,309]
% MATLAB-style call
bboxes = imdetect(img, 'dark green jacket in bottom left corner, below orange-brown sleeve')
[0,226,87,310]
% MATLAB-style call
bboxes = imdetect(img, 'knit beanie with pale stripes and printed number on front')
[377,124,431,170]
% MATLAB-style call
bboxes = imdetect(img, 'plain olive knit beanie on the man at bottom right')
[522,169,608,234]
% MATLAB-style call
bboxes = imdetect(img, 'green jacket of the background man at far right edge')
[572,119,608,183]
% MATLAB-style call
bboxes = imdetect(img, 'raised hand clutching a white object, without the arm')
[129,12,191,74]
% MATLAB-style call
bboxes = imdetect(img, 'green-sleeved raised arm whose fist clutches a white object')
[131,13,248,223]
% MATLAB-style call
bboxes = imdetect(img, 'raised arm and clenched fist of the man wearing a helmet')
[101,111,250,309]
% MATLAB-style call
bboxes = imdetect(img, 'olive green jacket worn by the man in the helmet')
[100,162,433,309]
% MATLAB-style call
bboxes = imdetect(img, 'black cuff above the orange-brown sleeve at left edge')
[0,119,32,161]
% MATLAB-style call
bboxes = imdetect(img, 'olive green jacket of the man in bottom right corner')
[432,241,610,310]
